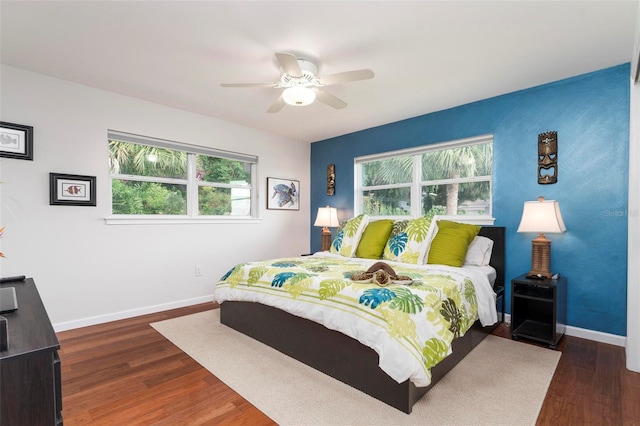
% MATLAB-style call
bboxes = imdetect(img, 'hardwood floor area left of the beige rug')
[58,304,275,426]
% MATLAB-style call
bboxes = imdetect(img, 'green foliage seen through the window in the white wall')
[109,140,251,216]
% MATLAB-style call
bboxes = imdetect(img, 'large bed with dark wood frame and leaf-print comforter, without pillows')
[214,218,505,413]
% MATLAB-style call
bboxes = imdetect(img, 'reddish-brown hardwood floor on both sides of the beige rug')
[58,304,640,426]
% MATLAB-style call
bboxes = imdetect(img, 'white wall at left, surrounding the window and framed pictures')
[0,66,310,331]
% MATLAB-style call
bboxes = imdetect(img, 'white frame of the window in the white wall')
[105,130,260,225]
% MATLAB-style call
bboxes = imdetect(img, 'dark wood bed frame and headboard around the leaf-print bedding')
[220,226,505,414]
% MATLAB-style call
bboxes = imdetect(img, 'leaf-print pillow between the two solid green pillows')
[382,216,431,264]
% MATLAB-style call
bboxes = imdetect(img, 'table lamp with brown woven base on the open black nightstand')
[517,197,567,279]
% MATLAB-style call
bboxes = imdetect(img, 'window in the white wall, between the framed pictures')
[108,131,258,218]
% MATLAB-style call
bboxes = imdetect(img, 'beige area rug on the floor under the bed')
[152,309,561,425]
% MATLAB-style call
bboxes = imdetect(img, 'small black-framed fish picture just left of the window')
[49,173,96,206]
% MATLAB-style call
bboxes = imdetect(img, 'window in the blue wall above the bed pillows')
[355,136,493,218]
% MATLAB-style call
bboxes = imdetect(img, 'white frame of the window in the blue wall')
[353,134,495,225]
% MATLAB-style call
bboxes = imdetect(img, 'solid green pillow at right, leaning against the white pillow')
[427,220,480,267]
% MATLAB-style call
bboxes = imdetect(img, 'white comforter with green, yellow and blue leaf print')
[214,252,497,386]
